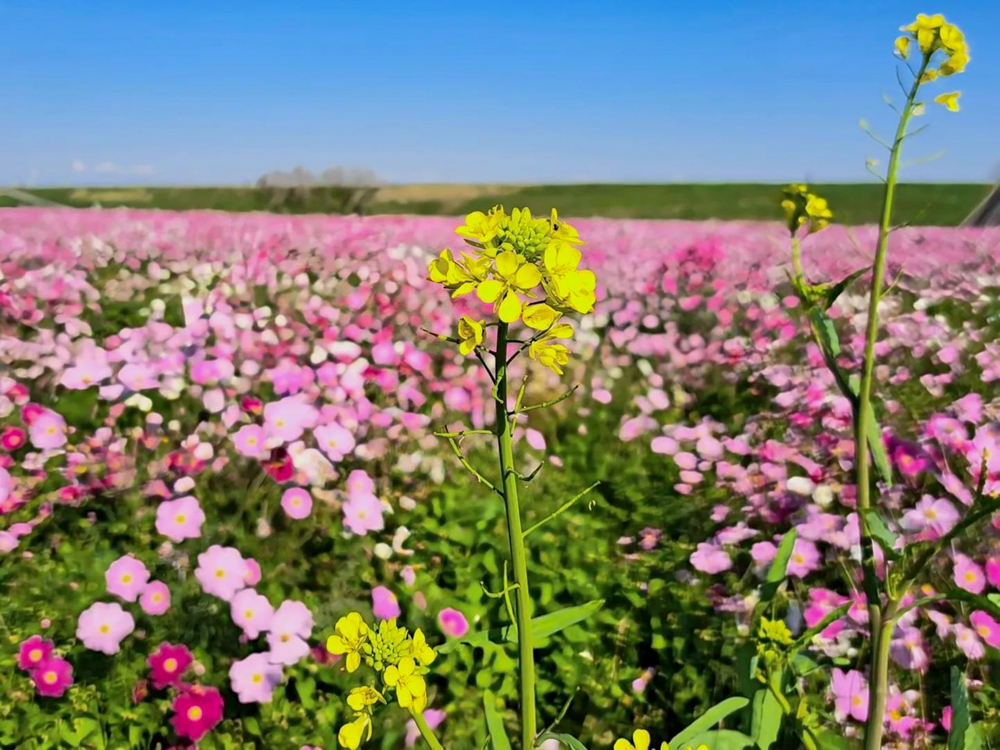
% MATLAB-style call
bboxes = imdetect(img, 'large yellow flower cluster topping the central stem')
[428,206,597,374]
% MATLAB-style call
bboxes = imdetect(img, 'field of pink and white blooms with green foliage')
[0,209,1000,750]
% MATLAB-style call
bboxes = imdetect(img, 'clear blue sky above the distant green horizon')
[0,0,1000,185]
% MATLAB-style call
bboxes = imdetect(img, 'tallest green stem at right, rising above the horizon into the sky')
[854,56,928,750]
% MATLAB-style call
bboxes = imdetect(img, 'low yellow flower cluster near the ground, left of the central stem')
[326,612,437,750]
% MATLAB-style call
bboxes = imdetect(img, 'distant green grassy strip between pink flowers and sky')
[0,183,991,226]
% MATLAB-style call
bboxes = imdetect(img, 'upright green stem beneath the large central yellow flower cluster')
[495,323,536,750]
